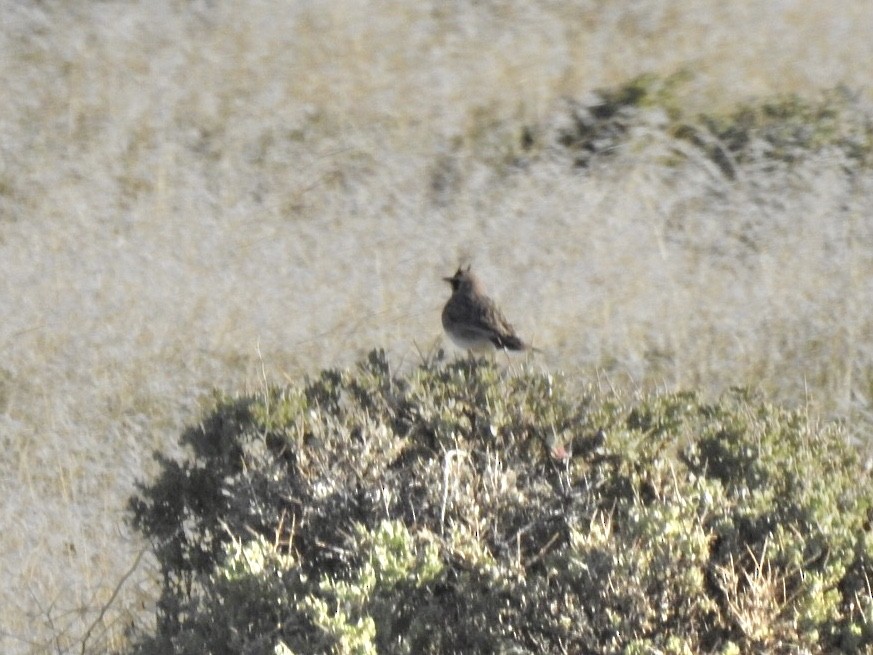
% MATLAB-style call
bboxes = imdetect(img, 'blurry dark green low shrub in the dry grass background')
[552,77,873,180]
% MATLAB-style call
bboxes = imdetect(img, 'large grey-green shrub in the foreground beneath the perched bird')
[130,351,873,655]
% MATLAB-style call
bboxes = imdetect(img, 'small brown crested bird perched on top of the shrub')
[443,265,535,350]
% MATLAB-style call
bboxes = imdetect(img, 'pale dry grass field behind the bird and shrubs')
[0,0,873,653]
